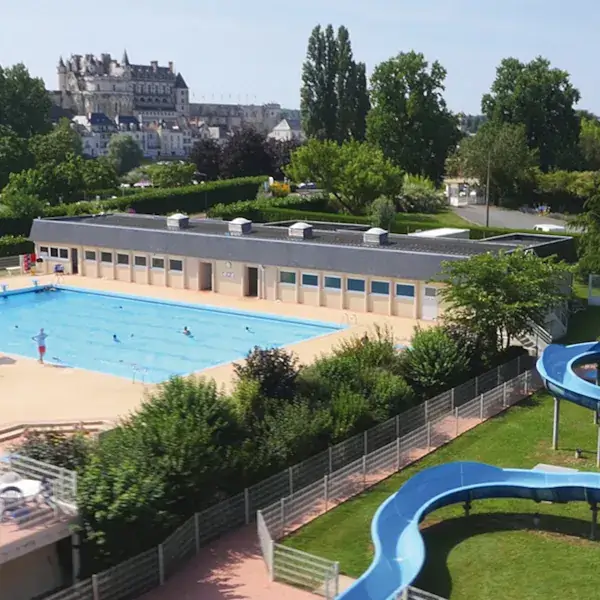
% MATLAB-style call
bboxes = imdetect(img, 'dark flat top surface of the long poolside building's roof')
[42,213,522,257]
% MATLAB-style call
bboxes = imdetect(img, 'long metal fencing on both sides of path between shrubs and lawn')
[46,356,541,600]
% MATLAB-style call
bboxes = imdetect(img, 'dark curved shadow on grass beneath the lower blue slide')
[414,511,597,598]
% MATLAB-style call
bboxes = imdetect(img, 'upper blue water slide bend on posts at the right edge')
[536,342,600,410]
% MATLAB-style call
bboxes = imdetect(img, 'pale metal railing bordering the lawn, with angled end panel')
[257,370,542,600]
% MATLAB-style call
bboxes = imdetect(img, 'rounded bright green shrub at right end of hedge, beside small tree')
[402,326,469,397]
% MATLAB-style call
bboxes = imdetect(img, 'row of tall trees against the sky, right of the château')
[301,26,600,191]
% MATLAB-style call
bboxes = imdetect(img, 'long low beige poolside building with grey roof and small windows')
[30,214,572,320]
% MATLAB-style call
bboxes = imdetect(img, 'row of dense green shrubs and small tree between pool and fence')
[19,252,565,573]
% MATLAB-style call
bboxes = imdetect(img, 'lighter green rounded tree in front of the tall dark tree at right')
[448,122,537,204]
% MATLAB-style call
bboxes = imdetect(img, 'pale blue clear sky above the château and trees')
[0,0,600,114]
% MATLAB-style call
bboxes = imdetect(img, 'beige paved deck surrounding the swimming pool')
[0,275,432,428]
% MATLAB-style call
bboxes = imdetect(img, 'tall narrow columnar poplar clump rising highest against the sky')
[300,25,370,143]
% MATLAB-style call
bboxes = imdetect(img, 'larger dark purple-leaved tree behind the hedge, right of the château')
[221,127,273,179]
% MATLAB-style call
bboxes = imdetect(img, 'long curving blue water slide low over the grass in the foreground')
[338,462,600,600]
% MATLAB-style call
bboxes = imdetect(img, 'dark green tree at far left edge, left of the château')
[0,64,52,138]
